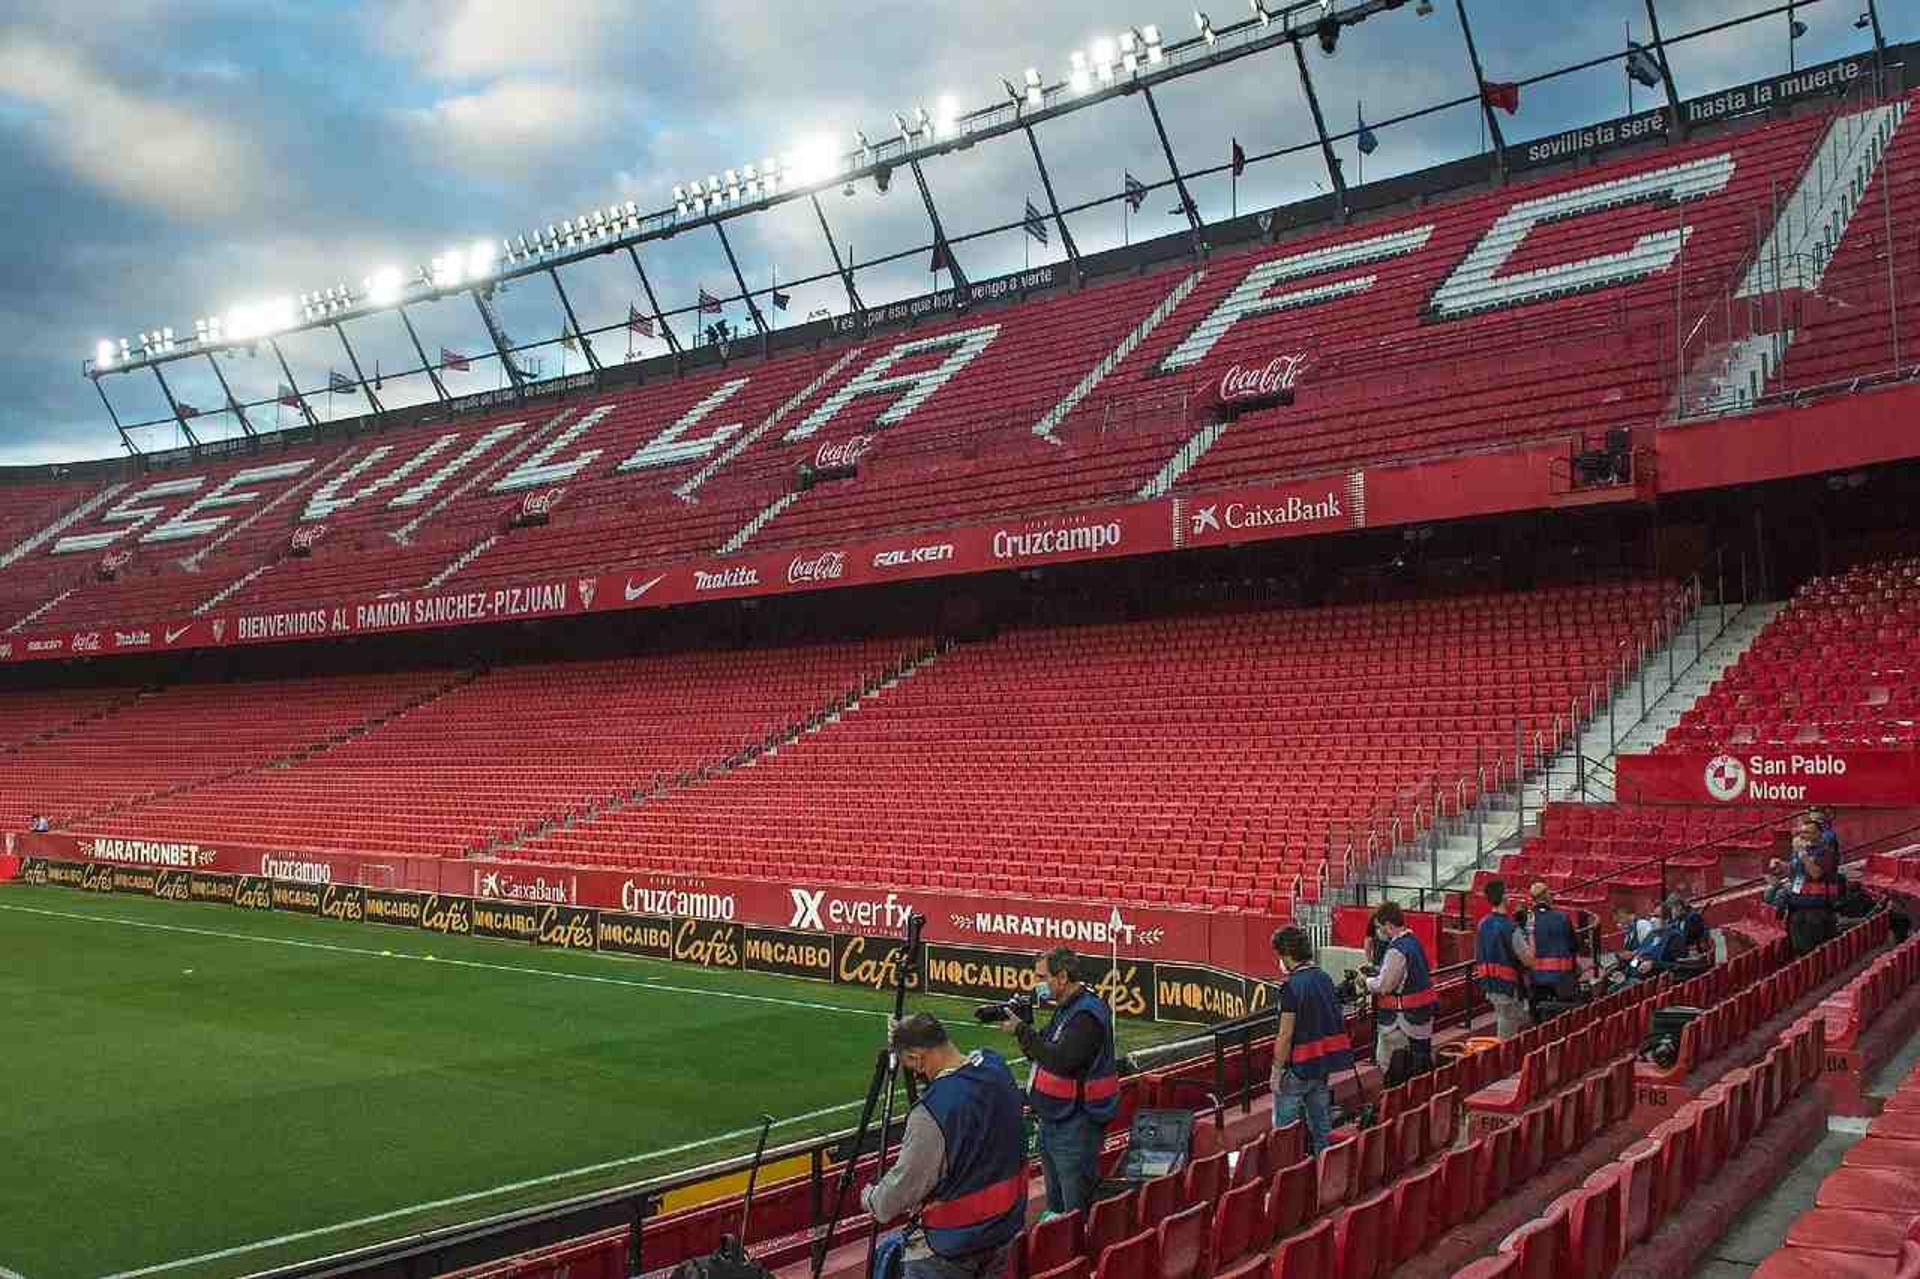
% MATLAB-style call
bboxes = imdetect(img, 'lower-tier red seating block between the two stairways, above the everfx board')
[507,584,1668,912]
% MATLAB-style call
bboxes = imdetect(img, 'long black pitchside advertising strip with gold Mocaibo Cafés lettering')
[19,857,1267,1024]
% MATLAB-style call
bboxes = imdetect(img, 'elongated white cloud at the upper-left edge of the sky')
[0,33,278,223]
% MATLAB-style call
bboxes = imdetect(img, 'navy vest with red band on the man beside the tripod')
[918,1049,1027,1258]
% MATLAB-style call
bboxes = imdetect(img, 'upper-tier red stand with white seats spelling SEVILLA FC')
[0,103,1889,628]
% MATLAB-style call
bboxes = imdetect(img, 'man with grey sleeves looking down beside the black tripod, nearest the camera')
[860,1012,1027,1279]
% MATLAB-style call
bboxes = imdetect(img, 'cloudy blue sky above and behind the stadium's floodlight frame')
[0,0,1896,465]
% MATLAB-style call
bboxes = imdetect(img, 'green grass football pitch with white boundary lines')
[0,885,1198,1279]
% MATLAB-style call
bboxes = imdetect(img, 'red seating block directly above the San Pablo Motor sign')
[1659,559,1920,751]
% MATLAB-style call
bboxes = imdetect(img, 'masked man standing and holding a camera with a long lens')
[1000,947,1119,1214]
